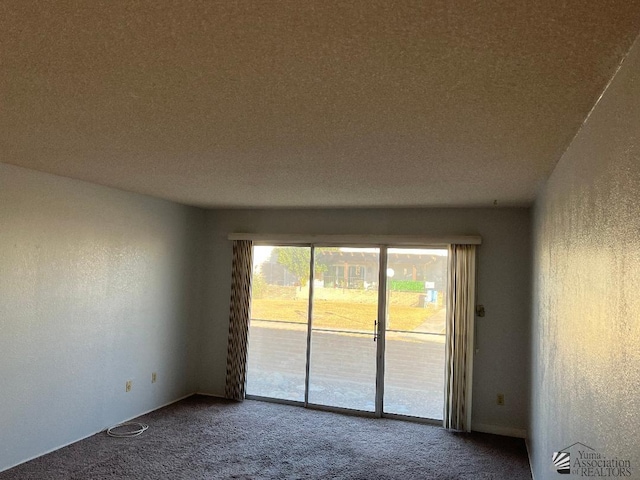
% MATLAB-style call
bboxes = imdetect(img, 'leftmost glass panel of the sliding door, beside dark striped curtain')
[246,246,311,402]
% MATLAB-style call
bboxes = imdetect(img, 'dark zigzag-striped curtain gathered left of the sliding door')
[224,240,253,401]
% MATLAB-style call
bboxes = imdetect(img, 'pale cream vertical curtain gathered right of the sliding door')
[444,245,476,432]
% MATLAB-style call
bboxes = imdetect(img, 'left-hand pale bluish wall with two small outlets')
[0,164,202,470]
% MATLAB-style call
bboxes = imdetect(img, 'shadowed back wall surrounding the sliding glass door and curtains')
[200,209,530,435]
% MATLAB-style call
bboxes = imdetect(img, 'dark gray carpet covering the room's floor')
[0,396,531,480]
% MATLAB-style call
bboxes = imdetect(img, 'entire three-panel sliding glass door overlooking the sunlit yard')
[246,246,447,419]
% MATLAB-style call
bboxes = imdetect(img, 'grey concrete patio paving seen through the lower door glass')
[247,322,444,419]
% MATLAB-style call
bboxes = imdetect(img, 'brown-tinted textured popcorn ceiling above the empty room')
[0,0,640,207]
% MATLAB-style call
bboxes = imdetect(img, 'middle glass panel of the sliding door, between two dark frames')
[308,247,379,412]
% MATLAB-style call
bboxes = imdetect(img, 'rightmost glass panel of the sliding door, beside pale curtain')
[384,248,447,419]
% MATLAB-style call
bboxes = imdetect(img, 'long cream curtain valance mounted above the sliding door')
[228,233,482,247]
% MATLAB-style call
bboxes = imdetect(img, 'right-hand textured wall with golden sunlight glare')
[530,36,640,480]
